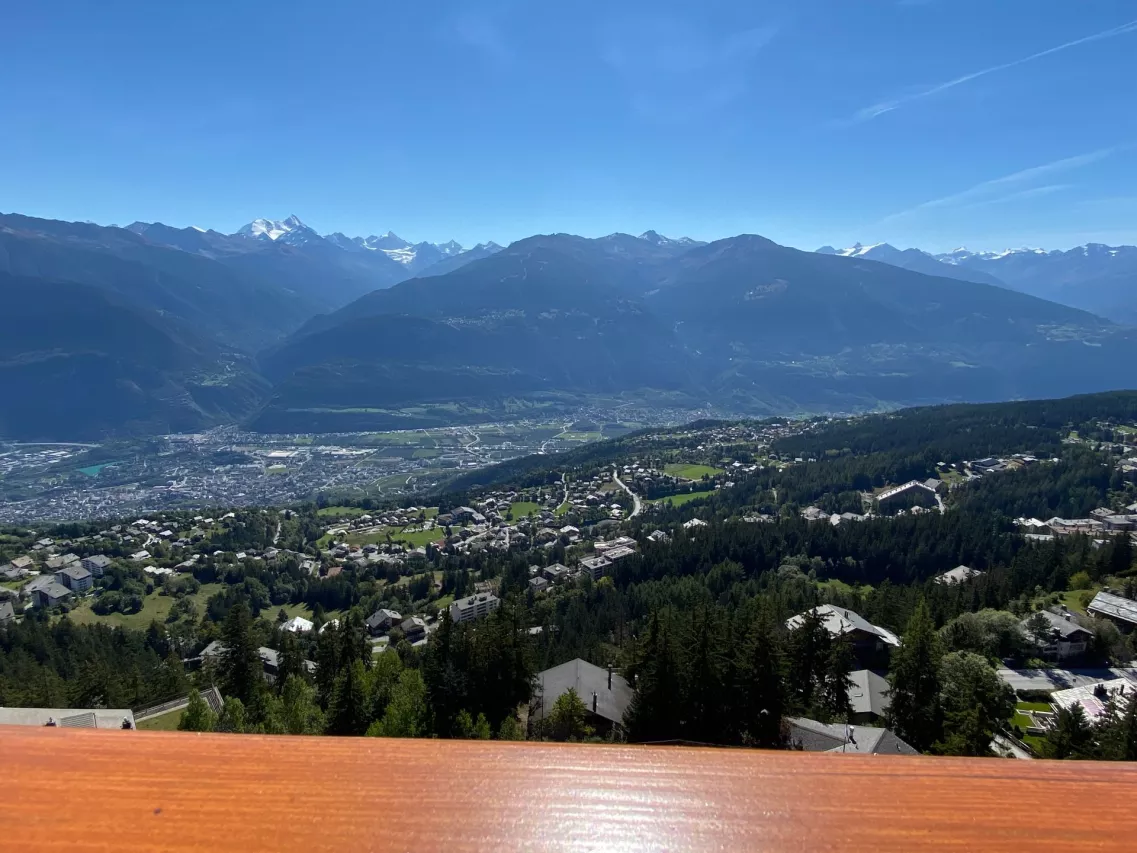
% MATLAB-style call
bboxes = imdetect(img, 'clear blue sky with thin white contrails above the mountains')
[0,0,1137,250]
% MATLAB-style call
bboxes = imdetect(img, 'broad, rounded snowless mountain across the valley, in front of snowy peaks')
[254,234,1137,431]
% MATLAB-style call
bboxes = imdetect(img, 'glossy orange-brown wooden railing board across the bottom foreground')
[0,727,1137,853]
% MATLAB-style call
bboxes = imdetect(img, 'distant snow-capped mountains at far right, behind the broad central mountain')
[818,243,1137,325]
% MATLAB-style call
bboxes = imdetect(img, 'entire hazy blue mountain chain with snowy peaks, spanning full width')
[0,214,1137,440]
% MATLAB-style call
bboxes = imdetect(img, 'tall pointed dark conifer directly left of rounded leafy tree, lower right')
[887,599,944,752]
